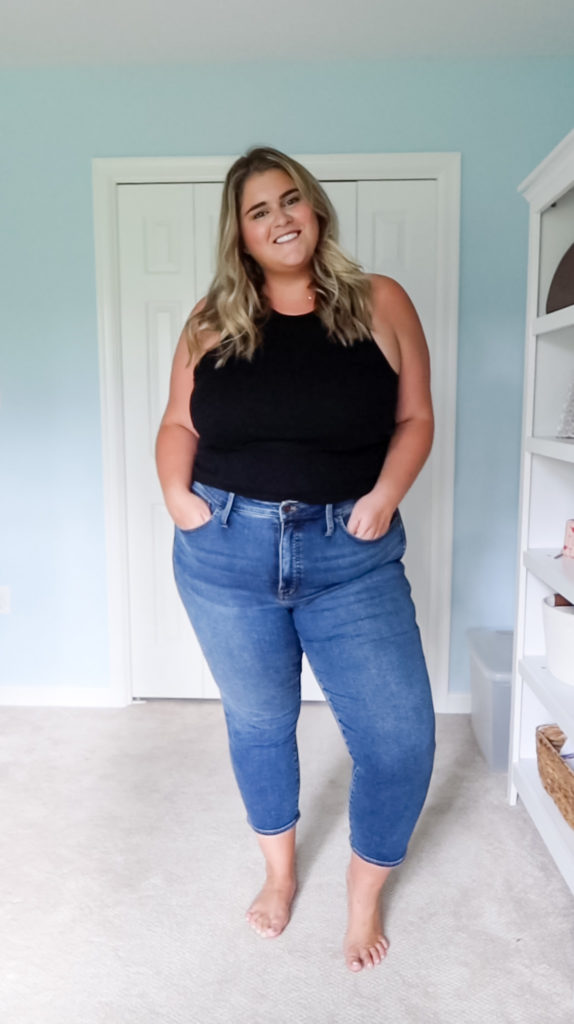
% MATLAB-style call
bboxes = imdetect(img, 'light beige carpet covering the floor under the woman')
[0,701,574,1024]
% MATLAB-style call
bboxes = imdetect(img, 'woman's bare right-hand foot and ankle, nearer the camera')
[344,855,389,972]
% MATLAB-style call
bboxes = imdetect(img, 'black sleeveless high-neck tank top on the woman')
[190,310,398,504]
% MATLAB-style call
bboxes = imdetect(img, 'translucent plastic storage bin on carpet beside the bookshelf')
[468,629,514,771]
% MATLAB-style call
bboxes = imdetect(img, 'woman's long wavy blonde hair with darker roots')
[185,146,371,366]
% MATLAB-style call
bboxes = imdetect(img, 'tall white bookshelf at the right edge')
[509,131,574,893]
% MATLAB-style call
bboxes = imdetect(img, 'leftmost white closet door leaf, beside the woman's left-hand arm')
[118,184,209,697]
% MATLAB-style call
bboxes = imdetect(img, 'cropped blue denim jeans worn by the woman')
[174,482,435,866]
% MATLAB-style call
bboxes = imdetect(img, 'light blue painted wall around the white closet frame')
[0,58,574,690]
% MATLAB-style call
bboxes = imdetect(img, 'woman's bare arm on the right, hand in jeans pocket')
[348,276,434,541]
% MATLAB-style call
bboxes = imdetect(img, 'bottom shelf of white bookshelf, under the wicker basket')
[513,760,574,893]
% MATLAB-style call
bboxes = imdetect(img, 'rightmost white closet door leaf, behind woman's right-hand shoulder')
[357,180,441,676]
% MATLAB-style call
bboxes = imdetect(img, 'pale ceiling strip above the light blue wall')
[0,0,574,68]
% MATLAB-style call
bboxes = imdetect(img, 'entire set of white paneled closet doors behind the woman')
[119,181,436,699]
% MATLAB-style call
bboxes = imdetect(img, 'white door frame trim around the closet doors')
[92,153,462,713]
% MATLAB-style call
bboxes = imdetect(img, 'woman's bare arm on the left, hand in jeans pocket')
[156,307,211,529]
